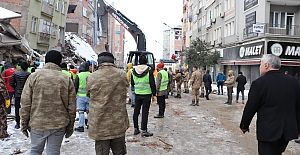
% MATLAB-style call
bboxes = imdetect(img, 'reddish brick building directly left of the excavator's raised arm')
[66,0,96,46]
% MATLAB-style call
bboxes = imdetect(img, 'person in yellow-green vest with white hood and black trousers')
[130,55,156,137]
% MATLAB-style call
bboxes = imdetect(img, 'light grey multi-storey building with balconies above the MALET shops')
[191,0,300,83]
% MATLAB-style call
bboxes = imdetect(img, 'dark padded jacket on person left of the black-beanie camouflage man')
[10,69,30,97]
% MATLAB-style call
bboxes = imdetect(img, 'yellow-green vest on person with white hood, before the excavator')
[132,69,152,95]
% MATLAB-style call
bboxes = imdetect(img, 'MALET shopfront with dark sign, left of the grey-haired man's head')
[221,41,265,84]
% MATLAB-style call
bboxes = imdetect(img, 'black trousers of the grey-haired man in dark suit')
[258,136,289,155]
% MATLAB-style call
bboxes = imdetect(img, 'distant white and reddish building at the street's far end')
[163,26,182,59]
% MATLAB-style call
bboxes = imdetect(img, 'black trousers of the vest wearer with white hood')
[133,94,152,130]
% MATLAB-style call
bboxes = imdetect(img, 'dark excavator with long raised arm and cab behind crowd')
[97,0,155,69]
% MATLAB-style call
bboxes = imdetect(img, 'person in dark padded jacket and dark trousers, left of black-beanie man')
[10,62,30,129]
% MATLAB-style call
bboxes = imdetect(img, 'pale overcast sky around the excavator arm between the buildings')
[106,0,183,60]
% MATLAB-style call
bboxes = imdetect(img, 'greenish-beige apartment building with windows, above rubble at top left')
[0,0,69,52]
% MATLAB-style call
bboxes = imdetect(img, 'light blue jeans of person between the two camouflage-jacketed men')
[77,96,90,127]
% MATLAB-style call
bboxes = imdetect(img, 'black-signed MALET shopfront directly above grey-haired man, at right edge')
[267,41,300,76]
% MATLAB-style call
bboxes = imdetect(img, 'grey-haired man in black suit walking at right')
[240,54,300,155]
